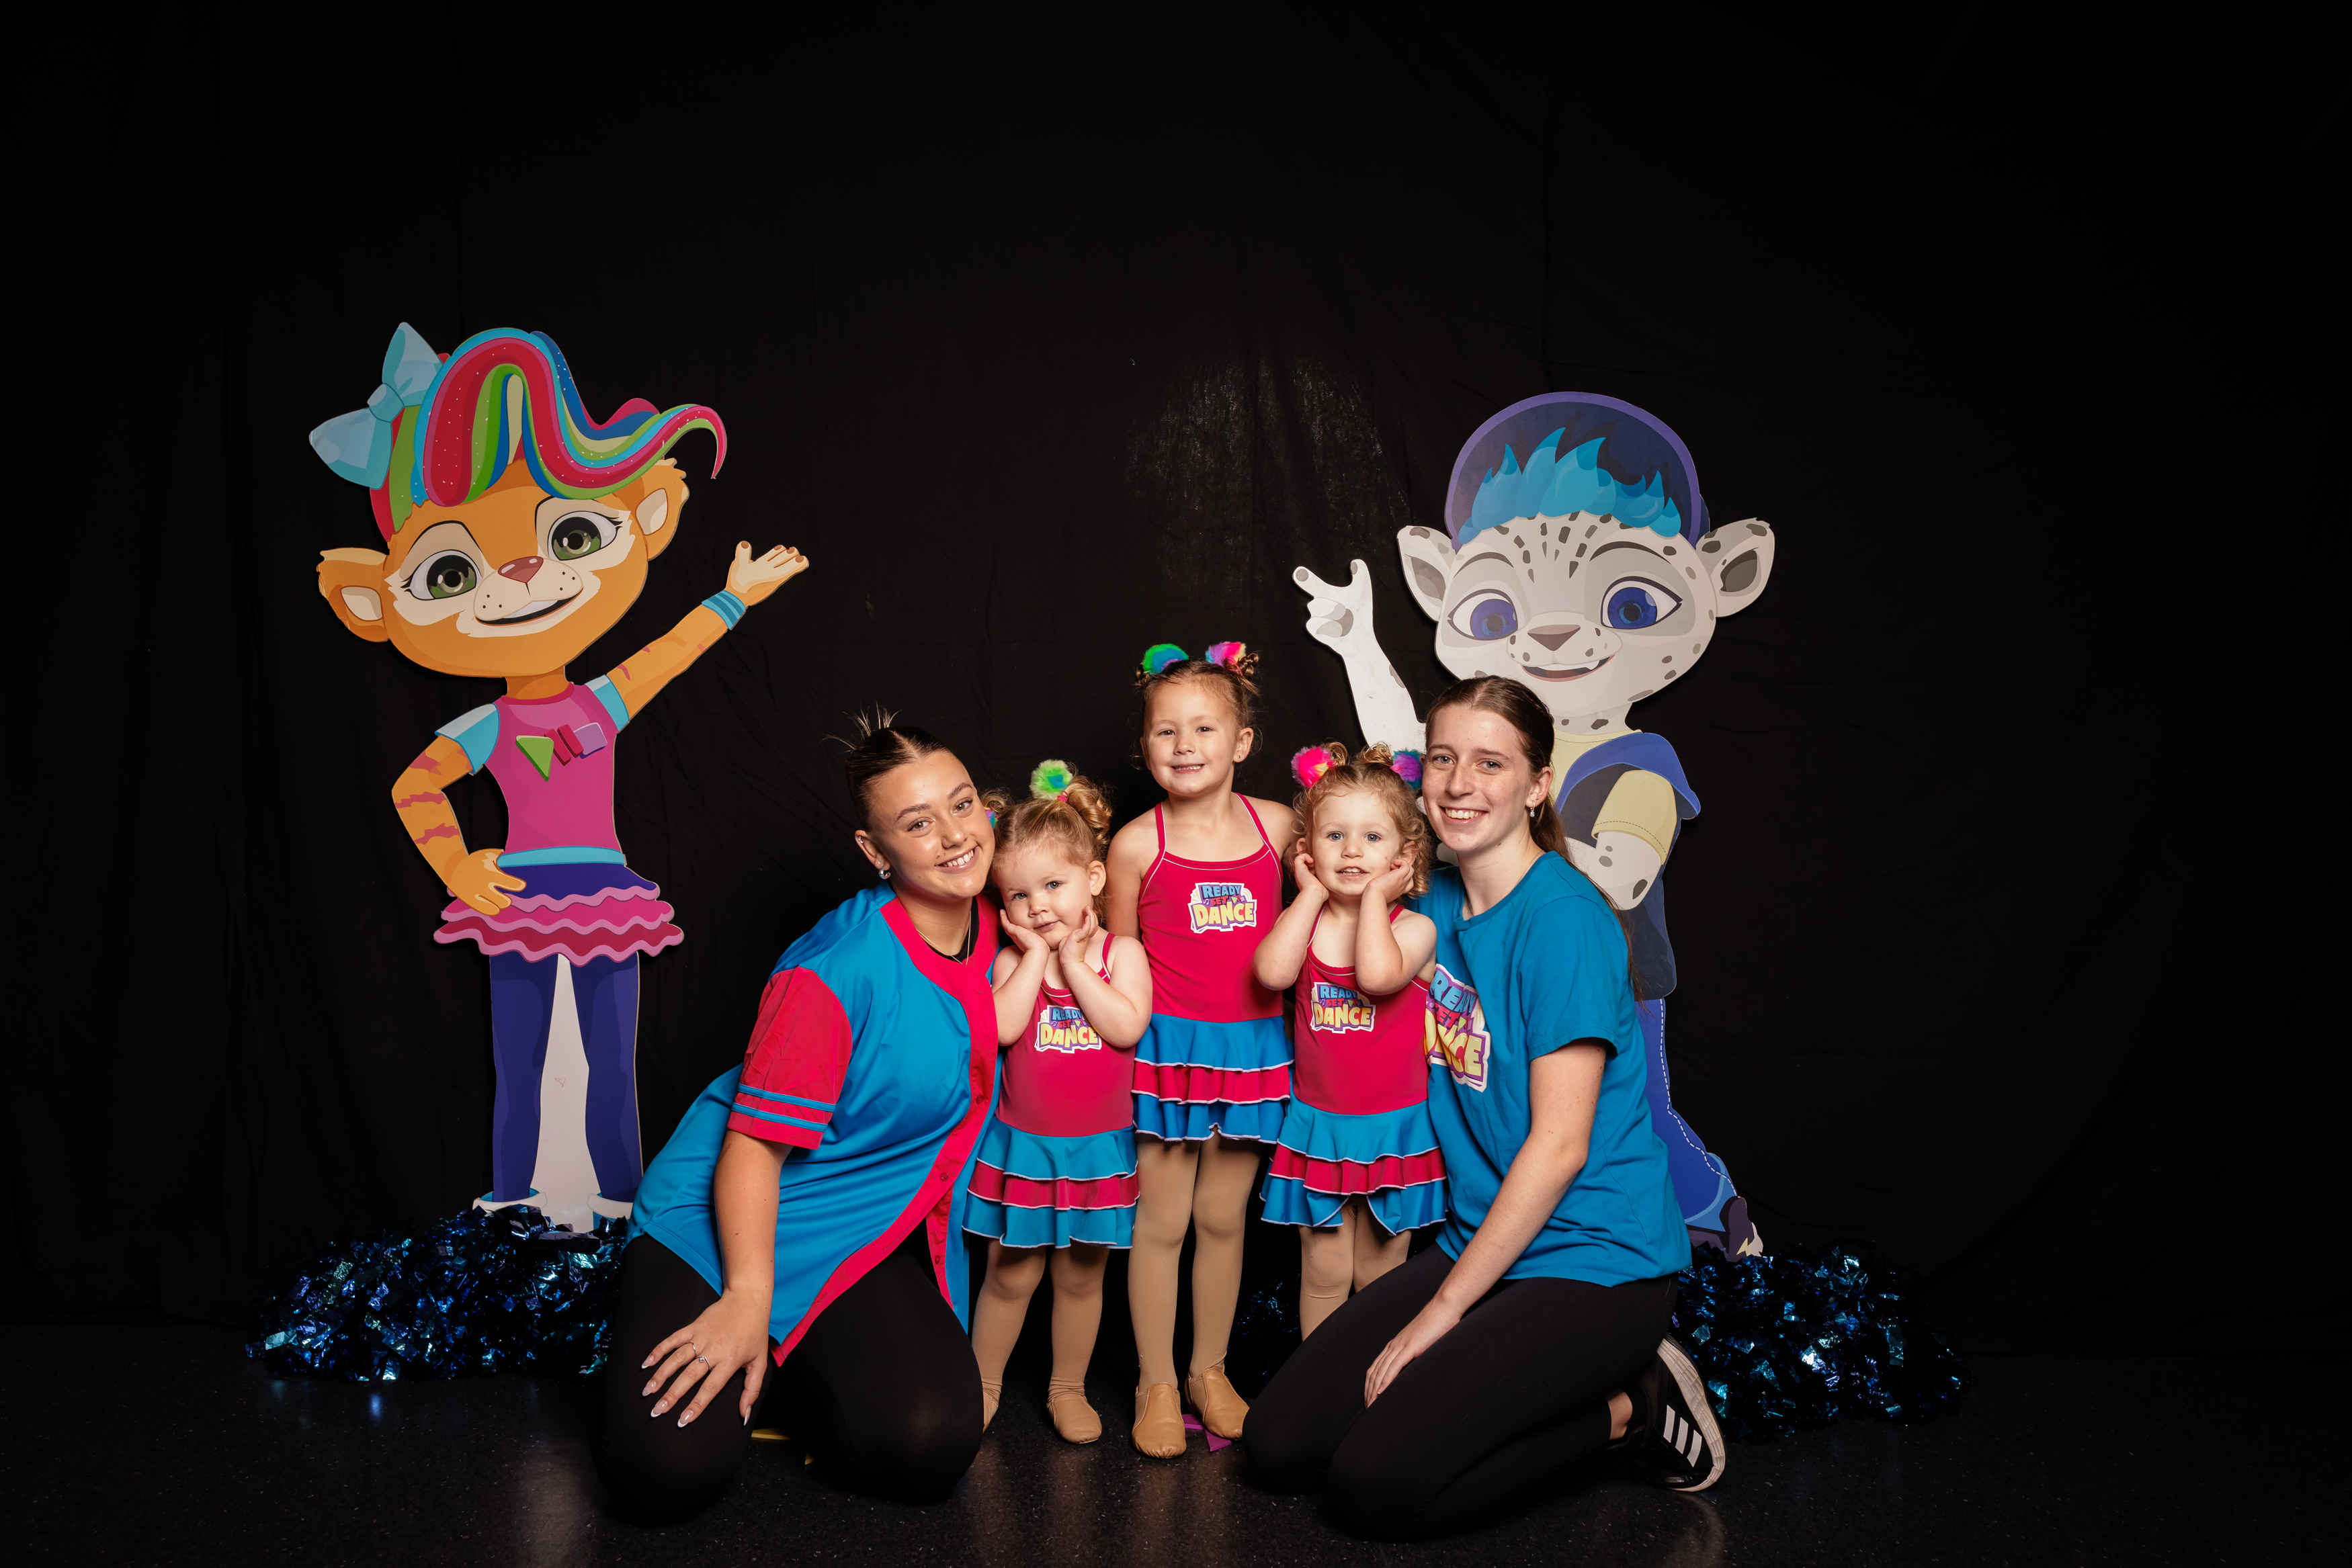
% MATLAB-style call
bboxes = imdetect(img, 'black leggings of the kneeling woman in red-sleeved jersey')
[595,1225,981,1519]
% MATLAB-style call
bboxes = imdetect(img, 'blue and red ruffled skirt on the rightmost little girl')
[1265,1100,1447,1237]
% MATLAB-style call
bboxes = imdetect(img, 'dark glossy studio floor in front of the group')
[13,1326,2352,1568]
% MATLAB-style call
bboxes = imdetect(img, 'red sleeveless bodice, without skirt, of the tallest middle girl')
[1136,797,1282,1025]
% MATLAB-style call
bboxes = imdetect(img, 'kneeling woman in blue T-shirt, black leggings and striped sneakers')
[1242,677,1724,1540]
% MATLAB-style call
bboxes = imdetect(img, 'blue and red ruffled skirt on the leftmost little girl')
[958,1117,1138,1246]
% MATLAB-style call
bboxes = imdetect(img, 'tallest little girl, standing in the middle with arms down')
[1108,642,1296,1460]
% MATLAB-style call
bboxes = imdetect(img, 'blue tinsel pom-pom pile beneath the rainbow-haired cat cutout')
[245,1206,628,1383]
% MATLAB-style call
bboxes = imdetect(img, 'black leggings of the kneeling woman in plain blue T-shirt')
[1242,1246,1675,1540]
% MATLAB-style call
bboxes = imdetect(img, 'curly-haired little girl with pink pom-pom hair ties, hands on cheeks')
[1256,745,1447,1336]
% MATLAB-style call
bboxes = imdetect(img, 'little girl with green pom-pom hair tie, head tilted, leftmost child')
[960,762,1152,1444]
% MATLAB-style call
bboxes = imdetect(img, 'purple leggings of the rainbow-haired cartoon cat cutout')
[489,952,644,1204]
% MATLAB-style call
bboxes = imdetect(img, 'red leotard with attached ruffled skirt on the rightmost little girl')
[1265,910,1447,1234]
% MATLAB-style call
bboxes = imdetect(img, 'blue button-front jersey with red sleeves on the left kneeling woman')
[635,889,997,1361]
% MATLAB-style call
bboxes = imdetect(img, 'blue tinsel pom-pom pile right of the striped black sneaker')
[1675,1244,1971,1444]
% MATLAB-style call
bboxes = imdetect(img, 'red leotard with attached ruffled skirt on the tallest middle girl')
[1134,797,1292,1143]
